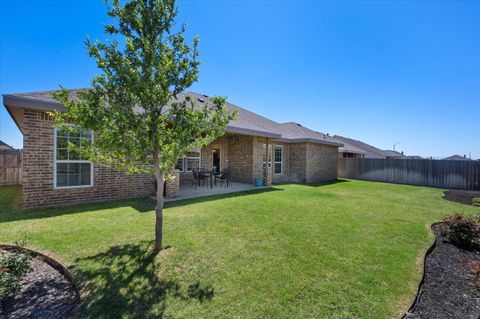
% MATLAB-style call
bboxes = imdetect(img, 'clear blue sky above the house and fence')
[0,0,480,158]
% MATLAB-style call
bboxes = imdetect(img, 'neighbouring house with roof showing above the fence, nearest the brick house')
[333,135,407,159]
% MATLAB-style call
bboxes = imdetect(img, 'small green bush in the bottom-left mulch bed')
[0,251,31,302]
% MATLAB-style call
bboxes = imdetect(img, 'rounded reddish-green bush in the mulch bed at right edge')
[442,213,480,248]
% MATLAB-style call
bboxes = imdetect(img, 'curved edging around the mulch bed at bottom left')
[0,243,82,319]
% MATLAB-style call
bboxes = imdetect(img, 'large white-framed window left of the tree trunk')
[53,128,93,188]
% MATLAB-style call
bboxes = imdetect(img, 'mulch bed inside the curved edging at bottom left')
[0,250,80,319]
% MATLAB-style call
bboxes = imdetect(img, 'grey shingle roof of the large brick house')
[3,89,343,146]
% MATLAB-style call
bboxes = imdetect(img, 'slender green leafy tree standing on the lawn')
[53,0,235,253]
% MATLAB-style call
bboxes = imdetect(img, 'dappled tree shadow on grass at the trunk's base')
[71,241,214,318]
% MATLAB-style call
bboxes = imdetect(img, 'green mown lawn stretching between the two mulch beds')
[0,181,480,319]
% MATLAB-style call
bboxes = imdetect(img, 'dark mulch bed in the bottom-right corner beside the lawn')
[403,224,480,319]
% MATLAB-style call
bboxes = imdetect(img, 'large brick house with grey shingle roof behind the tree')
[3,90,343,207]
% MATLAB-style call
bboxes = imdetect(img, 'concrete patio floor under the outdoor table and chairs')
[165,182,271,202]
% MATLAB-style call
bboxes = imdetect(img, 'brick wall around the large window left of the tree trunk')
[23,109,155,207]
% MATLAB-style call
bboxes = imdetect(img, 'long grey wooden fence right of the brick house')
[338,158,480,191]
